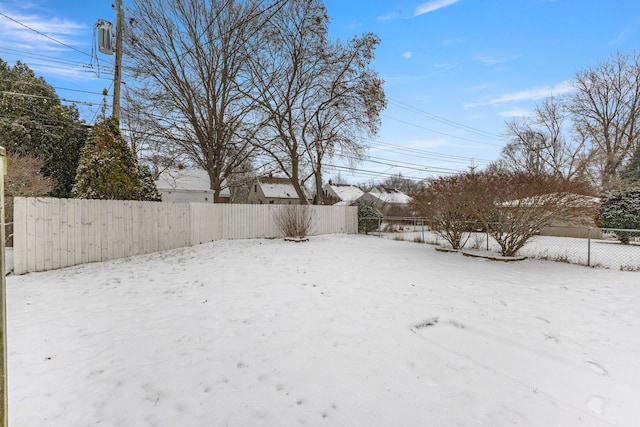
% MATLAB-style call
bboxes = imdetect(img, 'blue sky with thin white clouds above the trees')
[0,0,640,183]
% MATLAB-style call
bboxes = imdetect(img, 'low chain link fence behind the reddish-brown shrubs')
[371,217,640,271]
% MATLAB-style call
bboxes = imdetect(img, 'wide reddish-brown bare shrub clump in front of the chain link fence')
[412,170,591,256]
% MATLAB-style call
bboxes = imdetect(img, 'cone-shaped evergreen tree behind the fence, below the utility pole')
[74,118,142,200]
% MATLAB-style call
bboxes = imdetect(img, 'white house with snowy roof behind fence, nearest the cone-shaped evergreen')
[156,168,231,203]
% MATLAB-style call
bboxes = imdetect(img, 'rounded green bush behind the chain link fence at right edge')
[597,187,640,244]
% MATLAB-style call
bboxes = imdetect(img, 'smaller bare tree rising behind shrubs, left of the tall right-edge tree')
[499,97,588,179]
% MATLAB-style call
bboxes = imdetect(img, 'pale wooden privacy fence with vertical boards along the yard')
[13,197,358,274]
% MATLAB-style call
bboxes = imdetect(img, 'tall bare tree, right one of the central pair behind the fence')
[242,0,386,204]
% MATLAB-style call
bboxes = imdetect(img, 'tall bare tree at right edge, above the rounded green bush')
[569,52,640,189]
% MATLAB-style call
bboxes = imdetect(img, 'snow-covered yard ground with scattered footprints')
[7,235,640,427]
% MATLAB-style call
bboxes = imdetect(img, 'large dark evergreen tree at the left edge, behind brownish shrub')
[0,59,87,197]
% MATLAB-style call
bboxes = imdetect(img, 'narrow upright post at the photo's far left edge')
[0,147,9,427]
